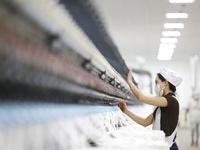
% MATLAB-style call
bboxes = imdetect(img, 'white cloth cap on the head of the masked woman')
[159,68,182,87]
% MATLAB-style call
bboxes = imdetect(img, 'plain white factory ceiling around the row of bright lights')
[92,0,200,62]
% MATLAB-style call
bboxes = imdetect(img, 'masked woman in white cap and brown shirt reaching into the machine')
[118,68,182,150]
